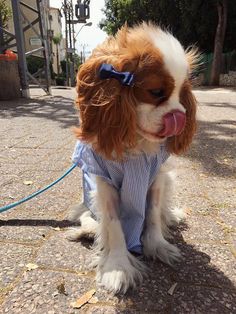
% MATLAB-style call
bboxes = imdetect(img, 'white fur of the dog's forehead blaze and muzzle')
[137,28,189,142]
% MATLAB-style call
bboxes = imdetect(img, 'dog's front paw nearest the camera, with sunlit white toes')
[97,252,146,293]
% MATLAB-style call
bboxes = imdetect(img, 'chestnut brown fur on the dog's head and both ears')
[75,24,196,159]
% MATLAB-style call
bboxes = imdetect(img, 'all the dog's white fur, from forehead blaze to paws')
[68,26,188,293]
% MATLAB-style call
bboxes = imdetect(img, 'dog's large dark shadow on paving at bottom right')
[113,225,236,314]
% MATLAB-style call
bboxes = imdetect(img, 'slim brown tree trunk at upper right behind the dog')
[210,0,227,86]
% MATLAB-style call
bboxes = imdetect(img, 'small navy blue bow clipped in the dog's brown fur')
[99,63,134,86]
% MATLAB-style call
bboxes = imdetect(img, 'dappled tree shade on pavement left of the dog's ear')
[0,96,78,128]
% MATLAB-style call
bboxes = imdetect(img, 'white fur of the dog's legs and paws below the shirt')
[67,162,184,293]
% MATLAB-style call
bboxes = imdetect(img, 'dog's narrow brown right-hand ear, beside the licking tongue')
[167,82,197,154]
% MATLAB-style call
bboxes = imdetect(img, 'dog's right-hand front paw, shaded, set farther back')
[143,230,182,266]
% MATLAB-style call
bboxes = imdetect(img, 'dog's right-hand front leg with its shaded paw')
[142,167,182,265]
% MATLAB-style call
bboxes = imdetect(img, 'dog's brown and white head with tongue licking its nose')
[76,23,196,159]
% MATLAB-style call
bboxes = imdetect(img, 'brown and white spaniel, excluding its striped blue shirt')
[68,23,197,292]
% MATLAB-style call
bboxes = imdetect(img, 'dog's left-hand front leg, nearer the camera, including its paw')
[97,177,145,293]
